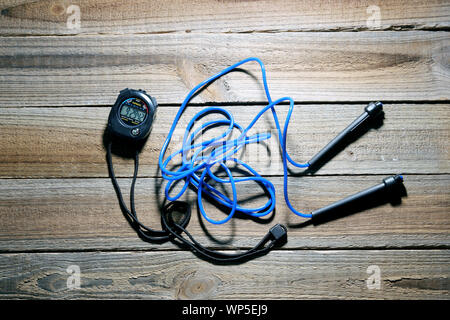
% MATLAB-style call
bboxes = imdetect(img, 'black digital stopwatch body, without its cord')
[108,88,158,142]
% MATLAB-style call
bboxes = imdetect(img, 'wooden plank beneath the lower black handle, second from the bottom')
[0,175,450,252]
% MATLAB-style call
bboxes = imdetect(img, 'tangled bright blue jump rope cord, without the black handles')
[159,57,311,224]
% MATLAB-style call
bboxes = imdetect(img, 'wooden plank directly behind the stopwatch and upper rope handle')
[0,104,450,178]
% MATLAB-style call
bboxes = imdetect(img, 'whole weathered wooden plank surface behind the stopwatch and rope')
[0,0,450,299]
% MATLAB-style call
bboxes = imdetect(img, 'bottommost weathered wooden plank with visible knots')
[0,250,450,300]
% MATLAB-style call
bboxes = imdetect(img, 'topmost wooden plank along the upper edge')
[0,0,450,35]
